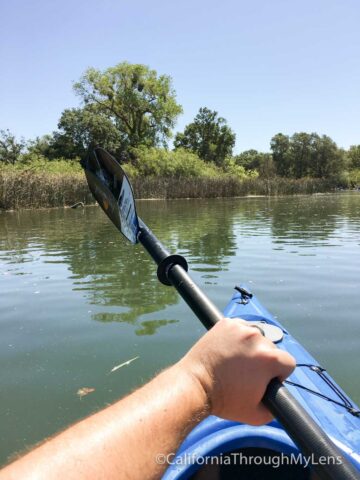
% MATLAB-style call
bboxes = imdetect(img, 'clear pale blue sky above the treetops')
[0,0,360,151]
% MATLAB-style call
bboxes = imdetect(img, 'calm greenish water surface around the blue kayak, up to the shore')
[0,193,360,463]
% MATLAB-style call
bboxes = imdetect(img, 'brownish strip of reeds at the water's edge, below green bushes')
[0,171,336,210]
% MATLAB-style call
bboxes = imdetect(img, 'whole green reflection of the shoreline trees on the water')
[0,195,360,335]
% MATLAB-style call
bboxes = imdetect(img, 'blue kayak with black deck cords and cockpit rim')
[163,287,360,480]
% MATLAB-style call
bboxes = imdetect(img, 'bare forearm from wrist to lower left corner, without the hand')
[0,365,208,480]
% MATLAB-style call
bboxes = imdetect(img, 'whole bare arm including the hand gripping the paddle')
[0,319,295,480]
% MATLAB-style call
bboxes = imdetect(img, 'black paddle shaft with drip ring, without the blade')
[138,218,359,480]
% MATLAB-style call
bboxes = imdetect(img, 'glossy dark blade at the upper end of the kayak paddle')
[85,148,139,243]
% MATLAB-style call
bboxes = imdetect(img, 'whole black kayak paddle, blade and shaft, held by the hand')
[85,148,359,480]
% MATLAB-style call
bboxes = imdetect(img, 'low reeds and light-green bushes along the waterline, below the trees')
[0,148,356,210]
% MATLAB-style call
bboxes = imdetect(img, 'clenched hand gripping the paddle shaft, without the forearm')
[179,318,296,425]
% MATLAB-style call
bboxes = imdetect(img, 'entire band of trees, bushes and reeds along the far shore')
[0,62,360,210]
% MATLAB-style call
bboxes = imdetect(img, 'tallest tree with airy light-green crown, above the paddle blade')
[74,62,182,149]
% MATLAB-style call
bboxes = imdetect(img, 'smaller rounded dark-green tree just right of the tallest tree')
[174,107,236,166]
